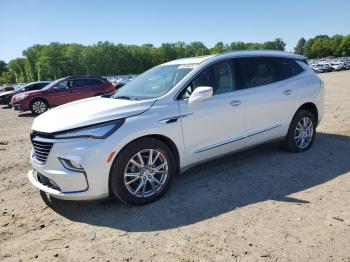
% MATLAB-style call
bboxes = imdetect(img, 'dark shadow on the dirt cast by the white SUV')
[42,133,350,232]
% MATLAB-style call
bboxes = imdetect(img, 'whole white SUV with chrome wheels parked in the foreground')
[28,51,324,204]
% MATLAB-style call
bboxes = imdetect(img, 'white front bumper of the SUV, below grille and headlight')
[28,139,113,200]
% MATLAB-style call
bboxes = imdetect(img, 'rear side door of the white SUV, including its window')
[238,57,296,146]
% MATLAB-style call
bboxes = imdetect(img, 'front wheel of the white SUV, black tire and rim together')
[109,138,176,205]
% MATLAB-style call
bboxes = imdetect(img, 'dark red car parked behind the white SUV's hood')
[11,76,116,115]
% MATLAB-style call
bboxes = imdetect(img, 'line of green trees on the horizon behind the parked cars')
[0,35,350,84]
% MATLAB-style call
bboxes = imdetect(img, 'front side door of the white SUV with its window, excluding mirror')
[179,60,245,166]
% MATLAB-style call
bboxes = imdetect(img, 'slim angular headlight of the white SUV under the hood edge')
[53,119,125,139]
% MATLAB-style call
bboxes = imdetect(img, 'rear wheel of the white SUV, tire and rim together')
[284,110,316,153]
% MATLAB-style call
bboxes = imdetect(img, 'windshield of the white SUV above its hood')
[112,64,196,100]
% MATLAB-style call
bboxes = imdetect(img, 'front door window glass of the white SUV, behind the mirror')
[180,60,237,99]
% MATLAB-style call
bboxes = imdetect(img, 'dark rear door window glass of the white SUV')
[237,57,279,88]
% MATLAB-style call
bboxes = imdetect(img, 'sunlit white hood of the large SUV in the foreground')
[32,97,156,133]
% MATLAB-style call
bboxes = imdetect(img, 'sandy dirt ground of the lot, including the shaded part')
[0,71,350,261]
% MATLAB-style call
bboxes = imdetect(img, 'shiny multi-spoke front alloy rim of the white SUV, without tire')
[124,149,168,198]
